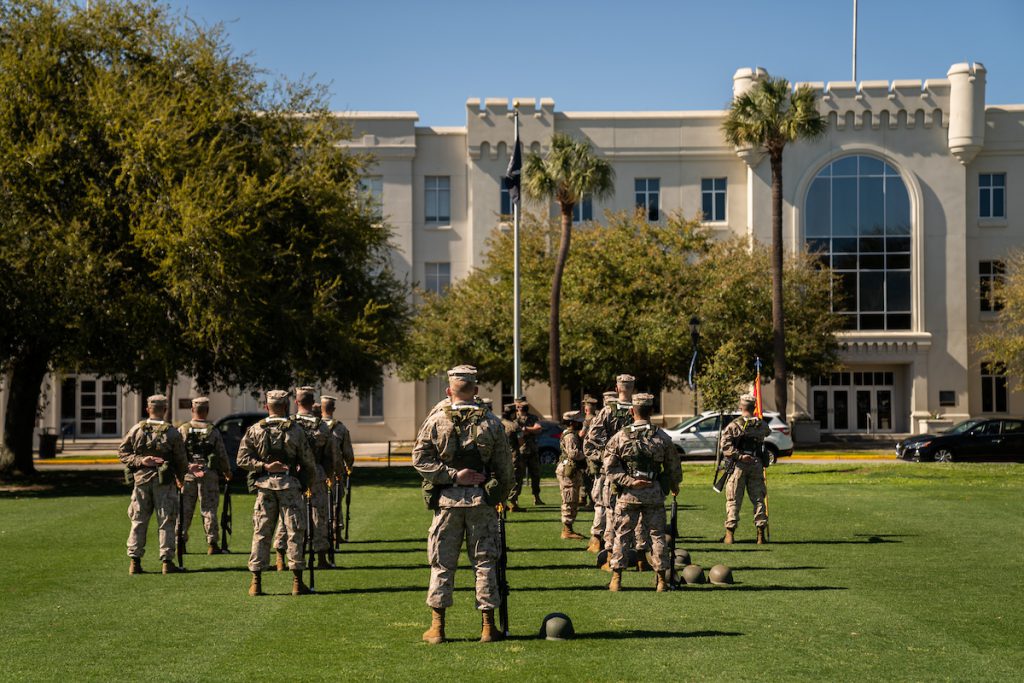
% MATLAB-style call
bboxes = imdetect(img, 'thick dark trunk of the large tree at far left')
[0,352,48,476]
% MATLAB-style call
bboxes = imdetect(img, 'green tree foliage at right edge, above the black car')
[974,250,1024,391]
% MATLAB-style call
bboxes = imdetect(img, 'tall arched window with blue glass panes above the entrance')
[804,156,910,330]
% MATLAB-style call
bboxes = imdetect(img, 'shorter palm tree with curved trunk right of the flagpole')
[522,133,615,413]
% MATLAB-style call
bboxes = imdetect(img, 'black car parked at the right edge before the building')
[896,418,1024,463]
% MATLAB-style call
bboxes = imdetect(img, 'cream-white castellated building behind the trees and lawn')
[6,63,1024,441]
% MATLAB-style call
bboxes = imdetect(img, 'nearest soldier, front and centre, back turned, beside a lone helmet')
[413,366,512,644]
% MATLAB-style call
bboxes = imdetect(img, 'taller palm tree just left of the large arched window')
[722,78,828,420]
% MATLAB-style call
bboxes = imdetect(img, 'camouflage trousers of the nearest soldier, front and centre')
[427,505,502,609]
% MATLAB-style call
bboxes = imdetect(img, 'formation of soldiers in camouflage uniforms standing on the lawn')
[118,366,770,644]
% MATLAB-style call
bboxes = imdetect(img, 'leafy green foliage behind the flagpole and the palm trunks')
[399,214,840,397]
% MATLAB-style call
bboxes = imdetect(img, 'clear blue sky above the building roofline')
[161,0,1024,126]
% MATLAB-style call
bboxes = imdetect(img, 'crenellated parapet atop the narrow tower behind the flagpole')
[466,97,555,161]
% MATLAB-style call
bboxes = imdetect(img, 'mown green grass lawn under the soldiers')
[0,464,1024,681]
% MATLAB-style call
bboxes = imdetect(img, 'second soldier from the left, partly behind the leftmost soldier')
[178,396,231,555]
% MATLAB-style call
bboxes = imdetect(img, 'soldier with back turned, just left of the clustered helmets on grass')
[604,393,683,592]
